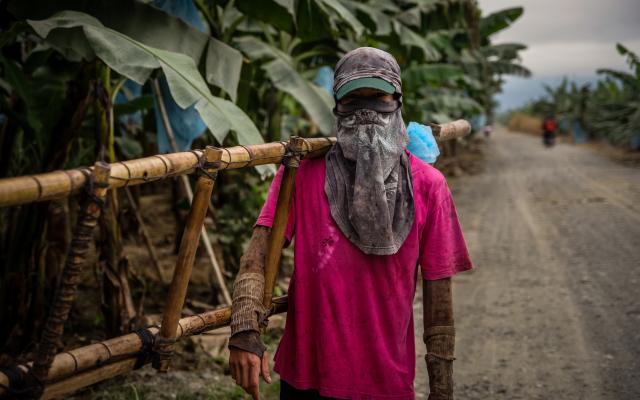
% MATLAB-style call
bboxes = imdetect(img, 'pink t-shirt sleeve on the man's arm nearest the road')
[418,179,473,280]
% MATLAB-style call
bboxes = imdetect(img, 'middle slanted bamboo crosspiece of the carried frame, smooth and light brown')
[153,147,222,372]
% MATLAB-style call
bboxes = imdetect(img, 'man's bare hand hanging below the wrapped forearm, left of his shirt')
[229,348,271,400]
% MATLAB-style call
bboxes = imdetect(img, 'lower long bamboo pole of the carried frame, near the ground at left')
[0,296,288,398]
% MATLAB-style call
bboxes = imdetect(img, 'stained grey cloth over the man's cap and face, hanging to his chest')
[324,48,415,255]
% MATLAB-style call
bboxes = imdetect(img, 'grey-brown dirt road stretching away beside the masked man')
[416,129,640,400]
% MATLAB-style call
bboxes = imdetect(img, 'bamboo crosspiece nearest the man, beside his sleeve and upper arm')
[262,136,305,310]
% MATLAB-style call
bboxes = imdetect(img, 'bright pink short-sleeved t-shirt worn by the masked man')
[256,155,471,400]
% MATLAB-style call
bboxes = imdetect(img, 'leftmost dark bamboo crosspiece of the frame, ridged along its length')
[32,161,110,390]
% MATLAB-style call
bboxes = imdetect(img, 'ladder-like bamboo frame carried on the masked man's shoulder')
[0,120,470,398]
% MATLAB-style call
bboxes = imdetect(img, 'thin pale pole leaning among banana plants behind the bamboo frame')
[153,79,231,304]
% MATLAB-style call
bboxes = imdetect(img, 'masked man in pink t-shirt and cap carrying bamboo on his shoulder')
[229,47,471,400]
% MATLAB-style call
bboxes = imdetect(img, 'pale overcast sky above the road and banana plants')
[479,0,640,110]
